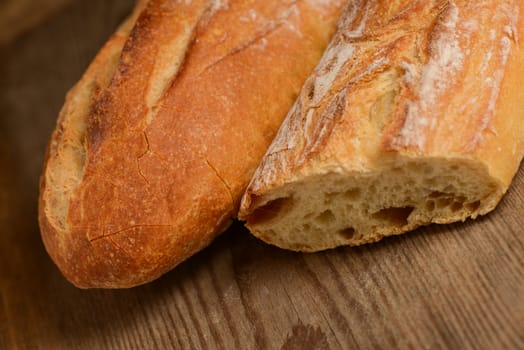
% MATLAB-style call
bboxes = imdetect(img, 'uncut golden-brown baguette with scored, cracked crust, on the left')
[39,0,343,288]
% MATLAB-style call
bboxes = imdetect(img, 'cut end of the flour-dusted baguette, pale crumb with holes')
[240,158,504,252]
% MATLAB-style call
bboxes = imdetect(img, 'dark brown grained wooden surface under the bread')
[0,0,524,350]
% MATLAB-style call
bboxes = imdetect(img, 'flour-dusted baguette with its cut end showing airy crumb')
[239,0,524,251]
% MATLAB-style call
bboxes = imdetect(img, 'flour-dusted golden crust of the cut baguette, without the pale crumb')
[239,0,524,251]
